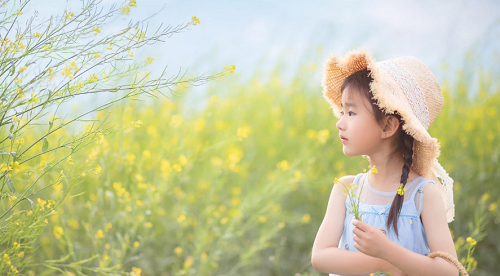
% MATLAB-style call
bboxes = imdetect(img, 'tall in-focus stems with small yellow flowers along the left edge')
[0,0,230,275]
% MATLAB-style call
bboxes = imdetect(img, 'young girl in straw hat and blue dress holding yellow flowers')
[312,50,458,276]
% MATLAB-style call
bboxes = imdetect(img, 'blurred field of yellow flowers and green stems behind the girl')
[5,61,500,275]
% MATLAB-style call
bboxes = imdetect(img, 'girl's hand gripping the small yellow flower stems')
[352,219,392,259]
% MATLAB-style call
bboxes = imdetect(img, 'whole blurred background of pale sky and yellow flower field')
[8,0,500,276]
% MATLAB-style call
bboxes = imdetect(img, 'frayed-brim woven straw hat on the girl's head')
[322,50,455,223]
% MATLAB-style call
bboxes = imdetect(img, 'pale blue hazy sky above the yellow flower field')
[10,0,500,111]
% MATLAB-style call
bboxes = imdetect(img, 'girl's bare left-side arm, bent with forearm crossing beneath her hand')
[311,176,401,275]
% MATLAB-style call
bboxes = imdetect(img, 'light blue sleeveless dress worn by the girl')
[329,173,435,276]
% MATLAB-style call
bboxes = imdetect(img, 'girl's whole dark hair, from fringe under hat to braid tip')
[340,69,414,237]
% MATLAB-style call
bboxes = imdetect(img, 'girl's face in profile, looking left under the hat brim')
[337,87,383,156]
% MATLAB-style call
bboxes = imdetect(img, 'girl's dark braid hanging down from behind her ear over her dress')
[387,119,414,238]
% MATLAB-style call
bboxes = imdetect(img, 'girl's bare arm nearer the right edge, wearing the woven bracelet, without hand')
[383,182,458,276]
